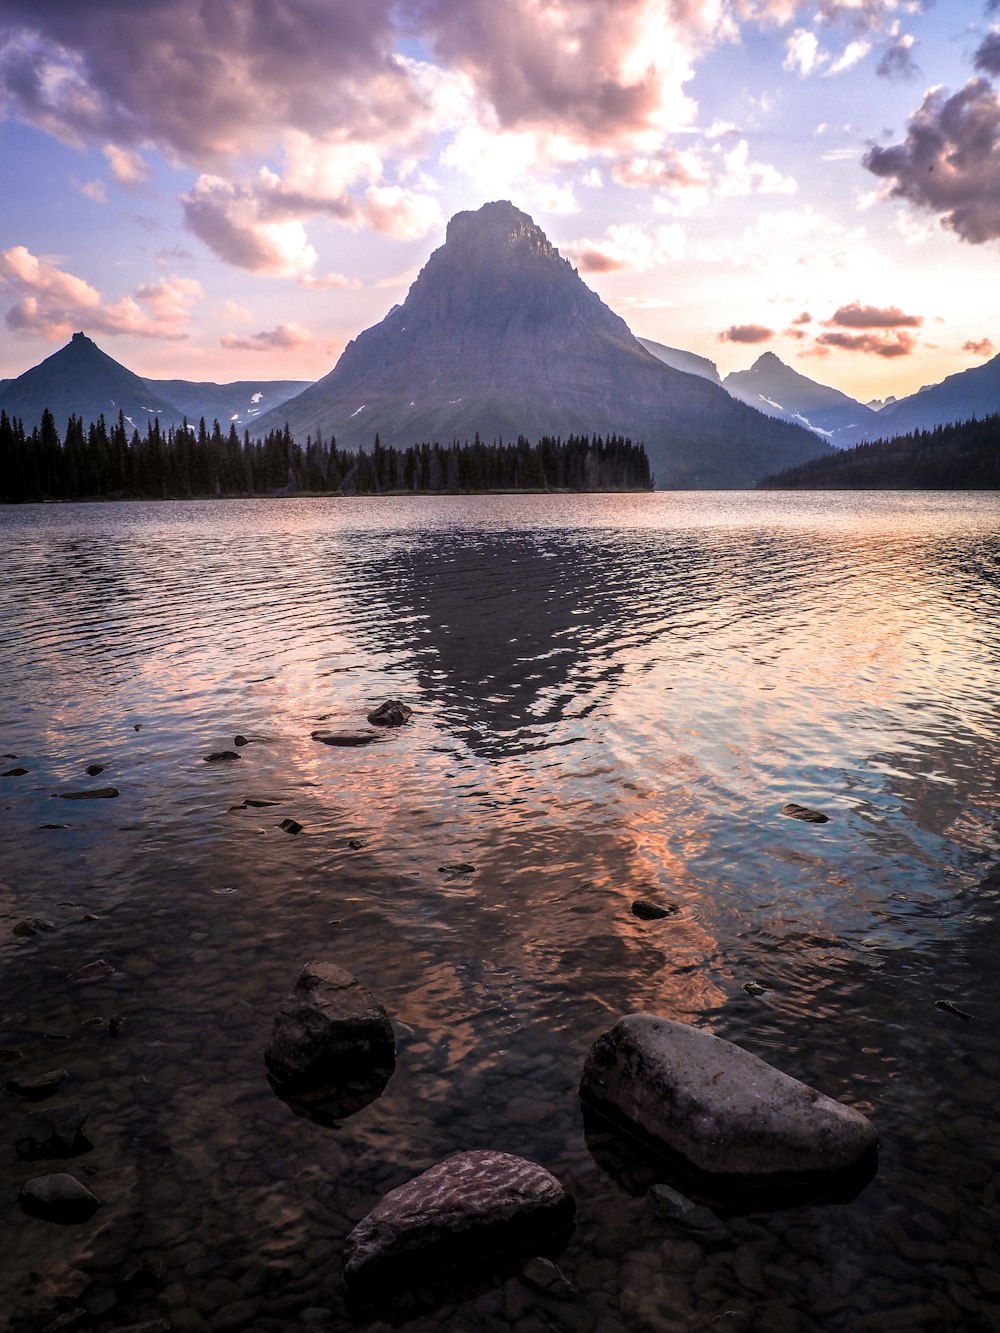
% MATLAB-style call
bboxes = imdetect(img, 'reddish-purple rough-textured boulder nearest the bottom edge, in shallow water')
[344,1150,575,1290]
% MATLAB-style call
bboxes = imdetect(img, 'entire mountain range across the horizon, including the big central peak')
[0,200,1000,487]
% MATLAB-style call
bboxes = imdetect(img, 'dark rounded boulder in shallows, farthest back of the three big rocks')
[264,962,396,1088]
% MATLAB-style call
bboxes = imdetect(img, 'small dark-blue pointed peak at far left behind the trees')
[0,333,180,432]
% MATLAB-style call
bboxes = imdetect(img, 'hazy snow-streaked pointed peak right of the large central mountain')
[723,352,876,448]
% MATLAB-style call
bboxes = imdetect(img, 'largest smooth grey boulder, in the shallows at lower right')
[580,1013,879,1180]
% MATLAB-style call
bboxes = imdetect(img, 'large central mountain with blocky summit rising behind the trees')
[256,200,828,487]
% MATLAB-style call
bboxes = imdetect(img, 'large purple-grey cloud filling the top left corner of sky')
[0,0,420,167]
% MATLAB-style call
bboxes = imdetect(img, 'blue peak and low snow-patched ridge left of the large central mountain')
[0,333,309,433]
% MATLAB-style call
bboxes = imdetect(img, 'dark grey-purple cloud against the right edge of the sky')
[863,79,1000,245]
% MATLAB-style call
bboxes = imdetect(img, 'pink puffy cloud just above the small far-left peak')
[0,245,204,340]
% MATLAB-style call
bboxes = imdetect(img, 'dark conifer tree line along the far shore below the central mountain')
[0,409,653,504]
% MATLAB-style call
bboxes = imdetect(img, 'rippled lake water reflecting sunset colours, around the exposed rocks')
[0,493,1000,1333]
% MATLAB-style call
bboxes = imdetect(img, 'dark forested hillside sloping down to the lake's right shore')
[759,413,1000,491]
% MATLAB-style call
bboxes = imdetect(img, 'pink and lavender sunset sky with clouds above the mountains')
[0,0,1000,401]
